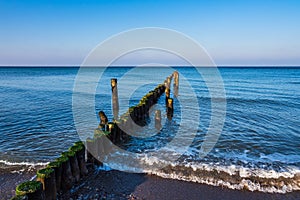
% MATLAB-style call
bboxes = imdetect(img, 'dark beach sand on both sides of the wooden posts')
[0,165,300,200]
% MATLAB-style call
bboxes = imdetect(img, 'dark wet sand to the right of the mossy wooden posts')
[59,166,300,200]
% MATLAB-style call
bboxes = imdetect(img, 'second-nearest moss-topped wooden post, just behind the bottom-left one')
[37,167,56,200]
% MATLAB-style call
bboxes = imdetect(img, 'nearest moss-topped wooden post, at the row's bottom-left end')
[16,181,45,200]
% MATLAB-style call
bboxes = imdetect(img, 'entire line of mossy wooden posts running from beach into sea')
[12,71,179,200]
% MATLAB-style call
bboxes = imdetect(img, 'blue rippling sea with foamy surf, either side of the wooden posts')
[0,67,300,193]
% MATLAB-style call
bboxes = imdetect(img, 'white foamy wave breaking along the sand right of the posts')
[103,152,300,193]
